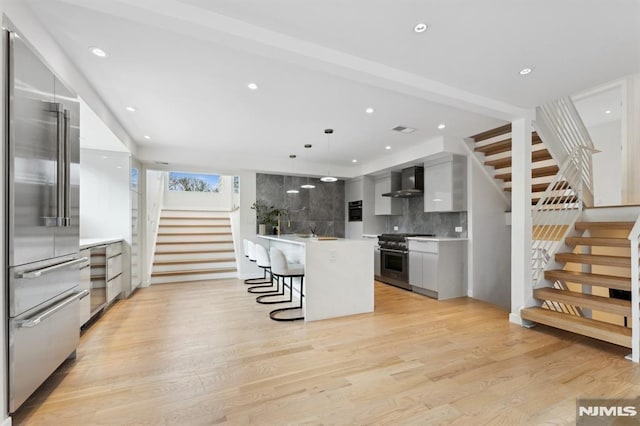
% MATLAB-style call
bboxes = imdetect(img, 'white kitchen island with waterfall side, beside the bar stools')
[257,235,373,321]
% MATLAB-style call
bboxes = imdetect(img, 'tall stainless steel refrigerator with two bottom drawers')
[3,25,86,412]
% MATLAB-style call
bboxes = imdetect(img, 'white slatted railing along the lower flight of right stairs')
[531,145,590,288]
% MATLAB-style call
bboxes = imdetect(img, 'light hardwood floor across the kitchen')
[14,280,640,425]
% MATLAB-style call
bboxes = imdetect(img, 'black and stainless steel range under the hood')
[378,234,434,290]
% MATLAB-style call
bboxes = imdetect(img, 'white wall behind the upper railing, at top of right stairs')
[587,120,623,206]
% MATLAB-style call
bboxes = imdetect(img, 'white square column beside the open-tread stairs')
[509,118,533,325]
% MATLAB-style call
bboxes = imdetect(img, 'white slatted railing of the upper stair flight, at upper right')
[534,97,598,206]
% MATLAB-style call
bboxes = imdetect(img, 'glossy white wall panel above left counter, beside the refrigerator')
[80,149,131,245]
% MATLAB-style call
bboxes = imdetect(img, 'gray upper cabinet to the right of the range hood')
[424,153,467,212]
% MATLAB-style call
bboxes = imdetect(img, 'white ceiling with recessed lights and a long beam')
[21,0,640,175]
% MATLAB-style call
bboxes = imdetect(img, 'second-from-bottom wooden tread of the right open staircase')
[533,287,631,317]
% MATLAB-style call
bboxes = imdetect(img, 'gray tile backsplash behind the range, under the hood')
[385,197,468,238]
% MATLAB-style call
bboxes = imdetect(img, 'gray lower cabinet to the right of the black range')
[409,240,467,300]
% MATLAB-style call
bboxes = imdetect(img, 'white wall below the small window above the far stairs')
[163,176,235,211]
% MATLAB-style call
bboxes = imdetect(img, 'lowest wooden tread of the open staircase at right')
[520,307,631,348]
